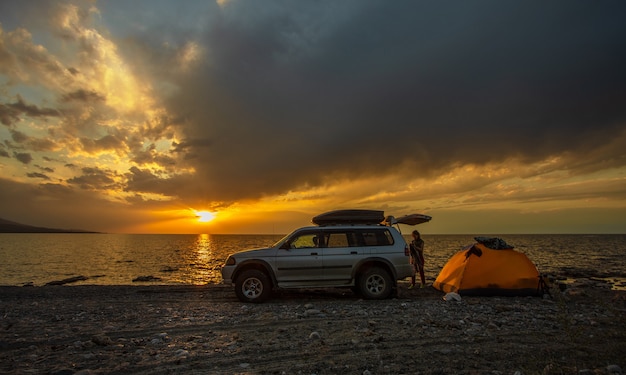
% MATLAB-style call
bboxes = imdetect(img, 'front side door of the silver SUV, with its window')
[275,230,323,287]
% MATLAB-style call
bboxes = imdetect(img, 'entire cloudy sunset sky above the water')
[0,0,626,235]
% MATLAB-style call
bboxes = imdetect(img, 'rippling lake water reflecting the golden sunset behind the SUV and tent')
[0,233,626,286]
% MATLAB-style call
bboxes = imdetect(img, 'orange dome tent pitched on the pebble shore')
[433,237,543,295]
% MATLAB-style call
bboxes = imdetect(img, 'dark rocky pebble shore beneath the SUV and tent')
[0,280,626,375]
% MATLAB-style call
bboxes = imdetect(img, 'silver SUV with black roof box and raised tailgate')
[222,210,430,302]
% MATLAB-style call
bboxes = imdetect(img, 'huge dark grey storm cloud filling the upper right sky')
[157,1,626,203]
